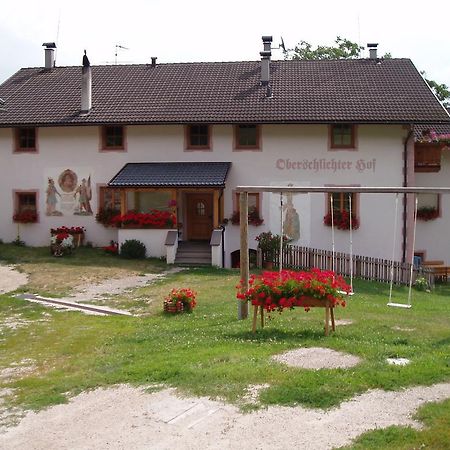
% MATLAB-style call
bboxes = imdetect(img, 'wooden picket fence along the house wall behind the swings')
[258,245,434,286]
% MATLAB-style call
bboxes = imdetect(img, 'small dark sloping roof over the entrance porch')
[108,162,231,188]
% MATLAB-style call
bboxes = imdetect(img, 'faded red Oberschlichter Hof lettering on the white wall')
[275,158,377,173]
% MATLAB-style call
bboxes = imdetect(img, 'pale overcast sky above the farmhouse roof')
[0,0,450,86]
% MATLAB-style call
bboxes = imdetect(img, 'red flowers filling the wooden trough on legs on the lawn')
[236,269,351,312]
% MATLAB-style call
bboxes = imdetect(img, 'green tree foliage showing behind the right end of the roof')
[284,36,450,108]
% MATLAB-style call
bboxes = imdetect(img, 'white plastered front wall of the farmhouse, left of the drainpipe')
[0,125,406,265]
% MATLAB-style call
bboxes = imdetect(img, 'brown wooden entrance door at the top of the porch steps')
[186,194,213,240]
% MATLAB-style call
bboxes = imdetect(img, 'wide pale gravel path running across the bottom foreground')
[0,383,450,450]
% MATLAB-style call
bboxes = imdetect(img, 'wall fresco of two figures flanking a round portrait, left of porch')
[45,168,93,216]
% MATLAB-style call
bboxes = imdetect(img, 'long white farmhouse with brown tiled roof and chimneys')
[0,36,450,267]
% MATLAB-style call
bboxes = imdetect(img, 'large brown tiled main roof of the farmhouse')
[0,59,450,126]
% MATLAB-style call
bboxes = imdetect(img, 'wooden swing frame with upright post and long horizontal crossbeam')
[236,186,450,320]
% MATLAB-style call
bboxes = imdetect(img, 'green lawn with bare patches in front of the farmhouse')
[0,245,450,442]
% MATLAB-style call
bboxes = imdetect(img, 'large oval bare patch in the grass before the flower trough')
[272,347,361,370]
